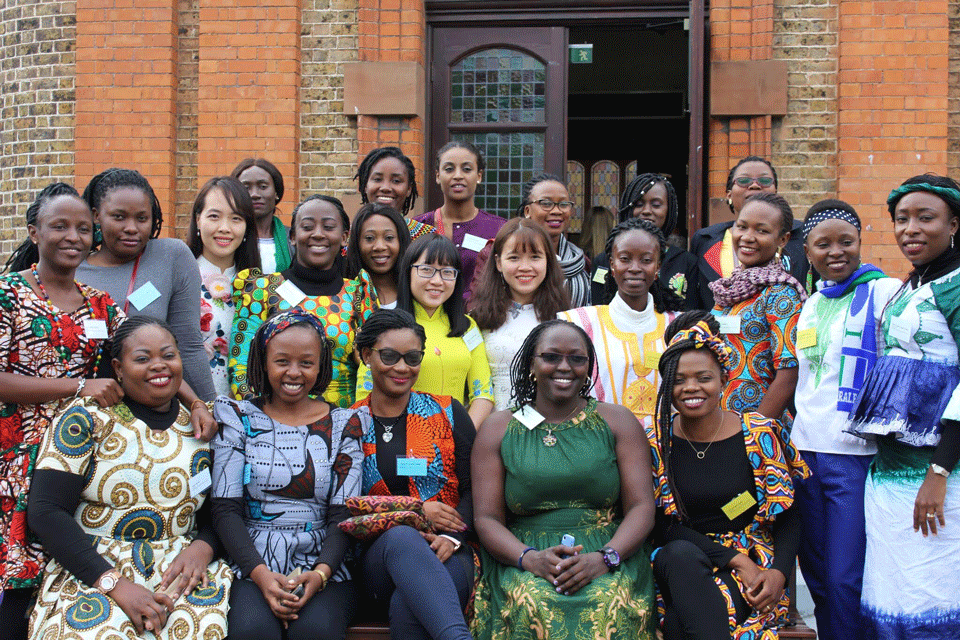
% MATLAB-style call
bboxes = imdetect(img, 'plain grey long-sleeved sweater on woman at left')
[77,238,217,401]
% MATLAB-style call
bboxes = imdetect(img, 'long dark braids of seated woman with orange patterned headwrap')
[654,309,723,520]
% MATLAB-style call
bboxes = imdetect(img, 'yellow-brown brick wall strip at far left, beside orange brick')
[0,0,76,256]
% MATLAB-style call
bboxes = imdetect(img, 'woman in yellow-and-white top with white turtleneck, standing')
[559,218,683,428]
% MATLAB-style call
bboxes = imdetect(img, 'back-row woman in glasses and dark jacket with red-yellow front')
[690,156,810,309]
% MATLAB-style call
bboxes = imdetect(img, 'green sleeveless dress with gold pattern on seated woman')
[473,399,656,640]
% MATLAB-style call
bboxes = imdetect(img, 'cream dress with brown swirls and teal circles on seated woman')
[30,399,232,640]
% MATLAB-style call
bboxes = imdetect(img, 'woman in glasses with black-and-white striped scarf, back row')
[520,173,590,308]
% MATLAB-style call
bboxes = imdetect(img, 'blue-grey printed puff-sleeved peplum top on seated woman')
[210,398,363,582]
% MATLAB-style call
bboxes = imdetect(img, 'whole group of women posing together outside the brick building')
[0,142,960,640]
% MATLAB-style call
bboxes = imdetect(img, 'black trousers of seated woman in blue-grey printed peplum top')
[227,580,356,640]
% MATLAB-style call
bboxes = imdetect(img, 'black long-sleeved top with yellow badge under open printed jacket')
[657,433,800,576]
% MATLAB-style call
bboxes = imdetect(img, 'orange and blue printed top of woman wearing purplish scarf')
[713,284,803,428]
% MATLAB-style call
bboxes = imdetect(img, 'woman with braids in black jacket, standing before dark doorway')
[592,173,698,309]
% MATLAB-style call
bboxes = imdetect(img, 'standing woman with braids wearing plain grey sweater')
[77,169,217,401]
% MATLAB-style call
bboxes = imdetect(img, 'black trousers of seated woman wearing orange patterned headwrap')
[653,540,750,640]
